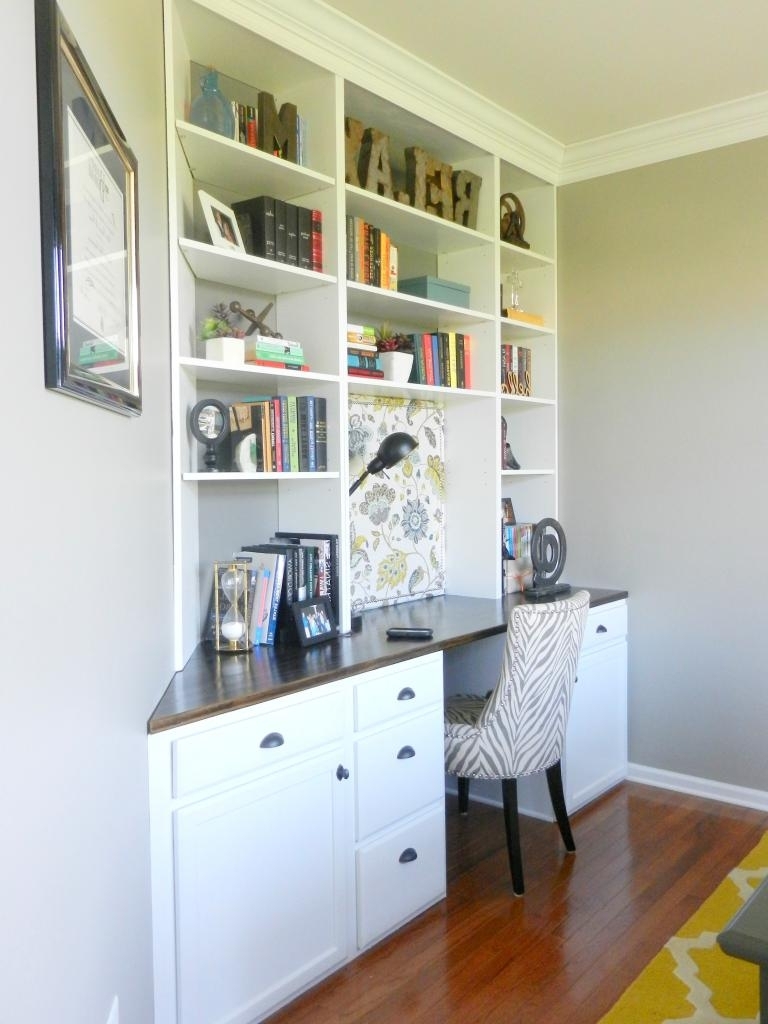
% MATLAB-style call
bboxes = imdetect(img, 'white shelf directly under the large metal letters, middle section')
[346,185,495,253]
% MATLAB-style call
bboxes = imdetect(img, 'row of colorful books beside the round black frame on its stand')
[225,394,328,473]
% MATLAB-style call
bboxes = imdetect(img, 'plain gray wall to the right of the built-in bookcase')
[559,139,768,791]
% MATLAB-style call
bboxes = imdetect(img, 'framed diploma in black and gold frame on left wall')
[35,0,141,416]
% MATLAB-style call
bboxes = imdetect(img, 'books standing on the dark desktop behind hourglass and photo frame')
[238,531,339,645]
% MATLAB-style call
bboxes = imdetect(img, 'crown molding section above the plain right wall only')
[557,92,768,184]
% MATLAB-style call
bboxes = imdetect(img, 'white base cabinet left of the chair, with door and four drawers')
[150,654,445,1024]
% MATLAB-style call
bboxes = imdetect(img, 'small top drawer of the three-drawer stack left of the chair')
[354,654,442,729]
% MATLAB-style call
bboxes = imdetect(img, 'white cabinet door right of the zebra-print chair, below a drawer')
[563,639,627,812]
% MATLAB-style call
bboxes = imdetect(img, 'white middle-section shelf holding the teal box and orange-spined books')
[347,281,496,331]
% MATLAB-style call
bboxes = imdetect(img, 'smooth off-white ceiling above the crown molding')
[317,0,768,145]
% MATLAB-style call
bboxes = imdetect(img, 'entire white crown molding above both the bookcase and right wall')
[195,0,768,185]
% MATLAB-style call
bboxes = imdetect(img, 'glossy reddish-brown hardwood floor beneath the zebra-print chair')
[269,783,768,1024]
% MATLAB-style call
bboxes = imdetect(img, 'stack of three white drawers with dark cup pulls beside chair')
[354,654,445,948]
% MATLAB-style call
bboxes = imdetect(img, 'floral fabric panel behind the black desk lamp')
[349,395,445,614]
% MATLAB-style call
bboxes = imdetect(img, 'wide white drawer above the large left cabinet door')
[173,692,344,797]
